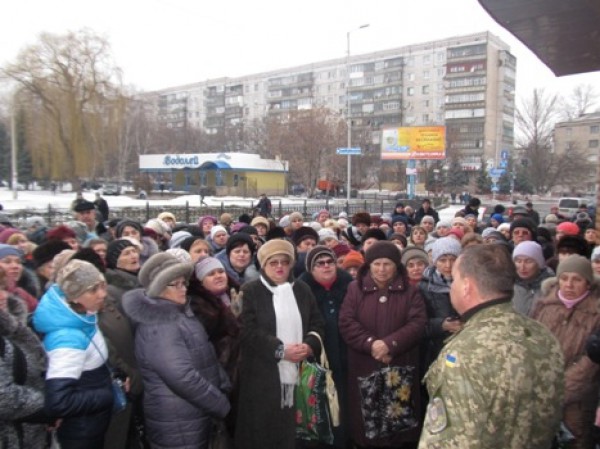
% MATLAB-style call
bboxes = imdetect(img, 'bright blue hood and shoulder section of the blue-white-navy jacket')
[33,284,98,338]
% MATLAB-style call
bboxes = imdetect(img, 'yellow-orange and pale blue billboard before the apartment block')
[381,126,446,161]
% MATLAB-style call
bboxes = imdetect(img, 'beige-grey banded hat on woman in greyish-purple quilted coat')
[138,253,194,298]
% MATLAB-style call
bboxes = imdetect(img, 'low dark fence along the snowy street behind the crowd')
[4,198,442,226]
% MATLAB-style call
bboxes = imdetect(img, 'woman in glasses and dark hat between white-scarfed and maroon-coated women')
[300,245,353,447]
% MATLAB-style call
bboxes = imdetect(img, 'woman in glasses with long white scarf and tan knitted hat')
[235,239,323,449]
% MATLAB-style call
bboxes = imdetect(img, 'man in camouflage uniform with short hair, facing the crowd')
[419,245,564,449]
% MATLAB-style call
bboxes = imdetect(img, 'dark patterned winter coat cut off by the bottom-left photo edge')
[0,295,47,449]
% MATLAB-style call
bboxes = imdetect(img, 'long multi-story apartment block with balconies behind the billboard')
[146,32,516,184]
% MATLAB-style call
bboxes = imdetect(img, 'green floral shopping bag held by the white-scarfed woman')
[294,332,339,444]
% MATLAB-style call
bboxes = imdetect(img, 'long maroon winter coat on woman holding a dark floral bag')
[339,272,427,447]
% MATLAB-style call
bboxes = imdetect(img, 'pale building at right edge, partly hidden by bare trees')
[554,112,600,194]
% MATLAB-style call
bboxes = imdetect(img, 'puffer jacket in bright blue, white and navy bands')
[33,284,113,441]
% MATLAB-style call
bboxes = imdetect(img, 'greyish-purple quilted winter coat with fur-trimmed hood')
[123,289,229,449]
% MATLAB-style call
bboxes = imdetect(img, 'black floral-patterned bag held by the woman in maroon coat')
[358,366,418,439]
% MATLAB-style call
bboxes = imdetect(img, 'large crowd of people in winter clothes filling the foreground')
[0,196,600,449]
